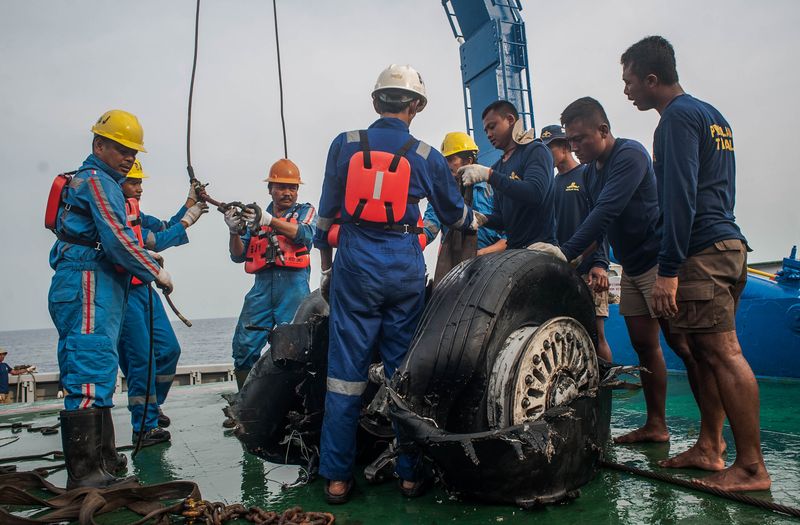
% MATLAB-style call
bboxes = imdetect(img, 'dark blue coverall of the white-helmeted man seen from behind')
[314,118,472,481]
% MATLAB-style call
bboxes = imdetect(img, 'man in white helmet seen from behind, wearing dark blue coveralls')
[314,64,485,503]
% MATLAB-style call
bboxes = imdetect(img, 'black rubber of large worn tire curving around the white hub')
[392,250,597,433]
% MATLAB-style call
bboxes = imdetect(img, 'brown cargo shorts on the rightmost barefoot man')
[669,239,747,333]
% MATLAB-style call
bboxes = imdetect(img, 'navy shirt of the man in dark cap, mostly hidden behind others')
[554,164,608,275]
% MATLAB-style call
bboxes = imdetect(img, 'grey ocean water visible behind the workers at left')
[0,317,236,372]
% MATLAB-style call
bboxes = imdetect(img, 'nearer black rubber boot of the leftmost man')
[59,408,129,490]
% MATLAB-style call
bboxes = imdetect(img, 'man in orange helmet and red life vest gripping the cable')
[225,159,317,389]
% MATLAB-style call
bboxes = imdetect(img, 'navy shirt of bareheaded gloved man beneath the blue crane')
[486,142,556,248]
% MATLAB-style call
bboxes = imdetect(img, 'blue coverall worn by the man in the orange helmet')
[231,203,317,370]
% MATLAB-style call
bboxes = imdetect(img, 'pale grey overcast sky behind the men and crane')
[0,0,800,330]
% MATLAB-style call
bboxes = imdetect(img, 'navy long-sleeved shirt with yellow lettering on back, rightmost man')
[653,95,746,277]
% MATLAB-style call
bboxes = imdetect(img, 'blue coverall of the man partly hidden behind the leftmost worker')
[119,206,189,432]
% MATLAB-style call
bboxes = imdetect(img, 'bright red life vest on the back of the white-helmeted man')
[344,130,417,224]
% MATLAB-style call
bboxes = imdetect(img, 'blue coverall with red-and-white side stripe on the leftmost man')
[48,155,159,410]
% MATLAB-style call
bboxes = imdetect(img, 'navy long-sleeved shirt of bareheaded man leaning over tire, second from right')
[561,138,660,276]
